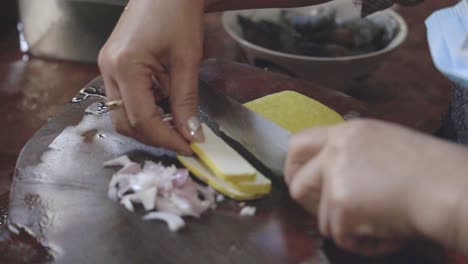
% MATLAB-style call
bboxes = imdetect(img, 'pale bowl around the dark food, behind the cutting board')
[222,0,408,90]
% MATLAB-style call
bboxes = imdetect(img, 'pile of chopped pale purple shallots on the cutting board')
[104,156,216,231]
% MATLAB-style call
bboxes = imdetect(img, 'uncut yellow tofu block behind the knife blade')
[244,91,344,133]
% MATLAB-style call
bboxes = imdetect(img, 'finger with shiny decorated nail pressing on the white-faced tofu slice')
[170,58,205,142]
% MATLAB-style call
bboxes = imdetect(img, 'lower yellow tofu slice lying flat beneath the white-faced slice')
[177,155,260,200]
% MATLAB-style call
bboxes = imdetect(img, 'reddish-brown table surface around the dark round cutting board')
[0,1,460,262]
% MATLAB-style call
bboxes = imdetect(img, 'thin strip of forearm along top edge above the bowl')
[205,0,330,12]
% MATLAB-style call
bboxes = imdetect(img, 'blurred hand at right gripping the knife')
[285,120,468,255]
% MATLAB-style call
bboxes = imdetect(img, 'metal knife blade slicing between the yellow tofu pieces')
[199,82,291,178]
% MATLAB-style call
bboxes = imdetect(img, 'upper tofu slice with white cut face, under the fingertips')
[190,124,257,182]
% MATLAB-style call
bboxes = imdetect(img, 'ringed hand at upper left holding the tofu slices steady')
[99,0,204,154]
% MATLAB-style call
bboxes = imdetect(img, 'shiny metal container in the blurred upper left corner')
[18,0,127,63]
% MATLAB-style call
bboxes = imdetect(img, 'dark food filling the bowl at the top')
[238,8,396,57]
